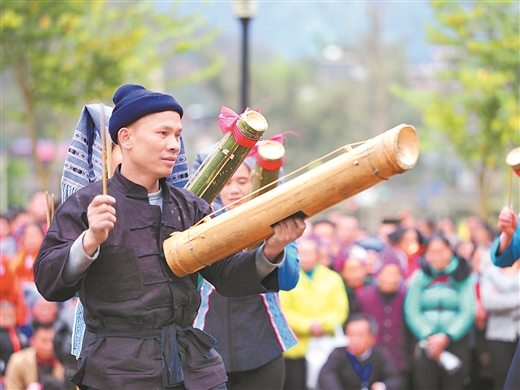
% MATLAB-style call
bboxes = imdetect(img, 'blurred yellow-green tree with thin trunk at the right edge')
[396,1,520,216]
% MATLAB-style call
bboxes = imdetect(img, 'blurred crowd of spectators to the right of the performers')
[281,211,520,390]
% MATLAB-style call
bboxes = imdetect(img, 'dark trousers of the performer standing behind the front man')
[227,355,284,390]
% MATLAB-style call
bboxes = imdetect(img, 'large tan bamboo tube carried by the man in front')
[163,124,419,277]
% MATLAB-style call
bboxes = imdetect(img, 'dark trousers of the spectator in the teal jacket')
[412,335,470,390]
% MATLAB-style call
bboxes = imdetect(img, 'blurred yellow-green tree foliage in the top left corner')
[0,1,216,113]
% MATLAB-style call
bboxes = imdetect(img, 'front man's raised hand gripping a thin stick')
[83,195,116,256]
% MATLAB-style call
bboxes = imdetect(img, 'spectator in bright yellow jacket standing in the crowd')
[280,238,348,390]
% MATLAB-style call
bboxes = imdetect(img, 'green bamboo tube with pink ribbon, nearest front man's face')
[185,111,267,203]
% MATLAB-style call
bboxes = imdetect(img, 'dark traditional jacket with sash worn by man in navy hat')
[35,170,278,389]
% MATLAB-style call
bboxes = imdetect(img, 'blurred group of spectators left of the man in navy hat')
[0,192,75,390]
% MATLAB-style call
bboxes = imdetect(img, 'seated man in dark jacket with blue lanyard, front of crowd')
[318,313,403,390]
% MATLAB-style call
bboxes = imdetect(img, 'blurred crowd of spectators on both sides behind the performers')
[0,192,520,390]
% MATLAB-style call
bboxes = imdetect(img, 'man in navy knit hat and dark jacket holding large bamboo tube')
[35,84,305,390]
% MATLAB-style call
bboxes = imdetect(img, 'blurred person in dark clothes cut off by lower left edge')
[0,300,29,383]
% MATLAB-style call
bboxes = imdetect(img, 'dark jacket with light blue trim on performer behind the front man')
[194,242,300,373]
